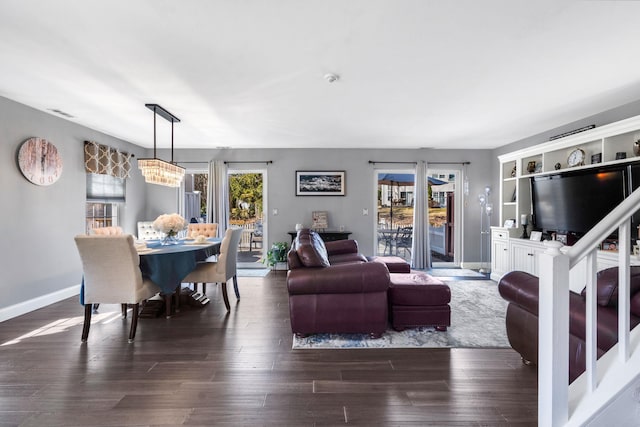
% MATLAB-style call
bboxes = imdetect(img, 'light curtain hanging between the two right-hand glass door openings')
[411,161,431,268]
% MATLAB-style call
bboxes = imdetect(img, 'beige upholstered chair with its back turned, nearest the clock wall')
[75,234,160,342]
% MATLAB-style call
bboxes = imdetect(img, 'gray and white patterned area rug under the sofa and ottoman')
[292,280,510,349]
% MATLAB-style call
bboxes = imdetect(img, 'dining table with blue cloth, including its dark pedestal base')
[136,237,222,318]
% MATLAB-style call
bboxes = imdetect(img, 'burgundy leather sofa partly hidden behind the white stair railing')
[498,267,640,383]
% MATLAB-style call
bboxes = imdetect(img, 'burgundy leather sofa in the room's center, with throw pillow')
[287,229,390,337]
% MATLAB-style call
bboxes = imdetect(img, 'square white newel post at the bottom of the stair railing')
[538,241,569,427]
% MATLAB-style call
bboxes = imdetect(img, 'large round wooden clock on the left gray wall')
[18,138,62,185]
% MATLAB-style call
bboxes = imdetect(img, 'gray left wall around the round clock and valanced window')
[0,98,146,313]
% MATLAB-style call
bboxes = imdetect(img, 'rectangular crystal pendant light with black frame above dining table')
[138,104,185,187]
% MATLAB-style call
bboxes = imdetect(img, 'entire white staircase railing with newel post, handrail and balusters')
[538,189,640,426]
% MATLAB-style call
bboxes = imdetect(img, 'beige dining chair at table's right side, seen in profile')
[182,228,243,311]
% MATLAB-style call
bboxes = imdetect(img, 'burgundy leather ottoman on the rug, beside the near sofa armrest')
[387,271,451,331]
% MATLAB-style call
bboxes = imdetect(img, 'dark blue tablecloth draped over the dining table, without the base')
[80,237,222,305]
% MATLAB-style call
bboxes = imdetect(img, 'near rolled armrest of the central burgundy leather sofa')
[287,263,390,295]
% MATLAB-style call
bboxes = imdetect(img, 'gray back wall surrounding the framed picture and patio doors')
[174,149,497,262]
